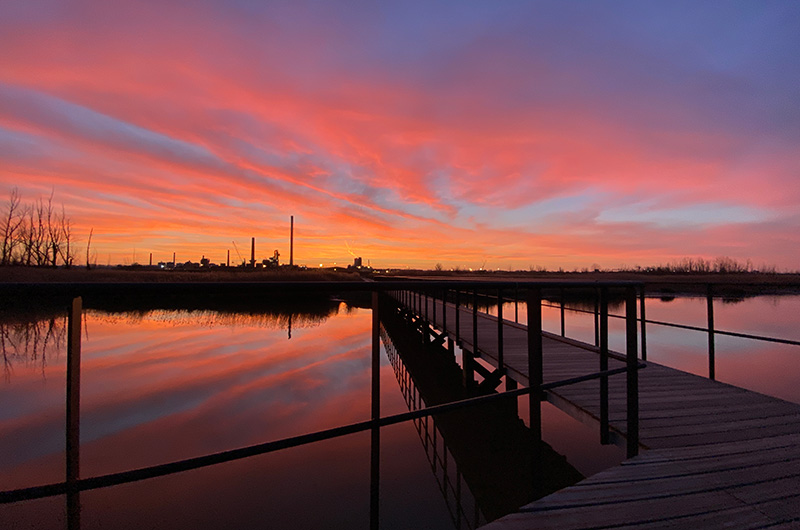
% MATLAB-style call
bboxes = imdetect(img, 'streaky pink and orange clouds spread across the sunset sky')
[0,2,800,268]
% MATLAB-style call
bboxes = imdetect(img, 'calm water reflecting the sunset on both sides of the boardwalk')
[0,290,800,529]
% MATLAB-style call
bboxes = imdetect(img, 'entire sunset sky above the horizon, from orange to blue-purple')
[0,0,800,270]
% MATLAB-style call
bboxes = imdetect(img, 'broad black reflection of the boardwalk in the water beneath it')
[382,311,583,528]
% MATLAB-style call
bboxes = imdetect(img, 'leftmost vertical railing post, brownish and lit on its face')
[66,297,83,530]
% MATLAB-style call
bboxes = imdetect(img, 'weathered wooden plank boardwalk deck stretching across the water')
[401,290,800,530]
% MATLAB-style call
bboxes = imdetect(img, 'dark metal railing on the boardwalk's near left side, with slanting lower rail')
[0,281,644,529]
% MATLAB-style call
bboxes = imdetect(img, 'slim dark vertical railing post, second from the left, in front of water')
[369,291,381,530]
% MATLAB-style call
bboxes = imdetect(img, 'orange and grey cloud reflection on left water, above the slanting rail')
[0,311,371,485]
